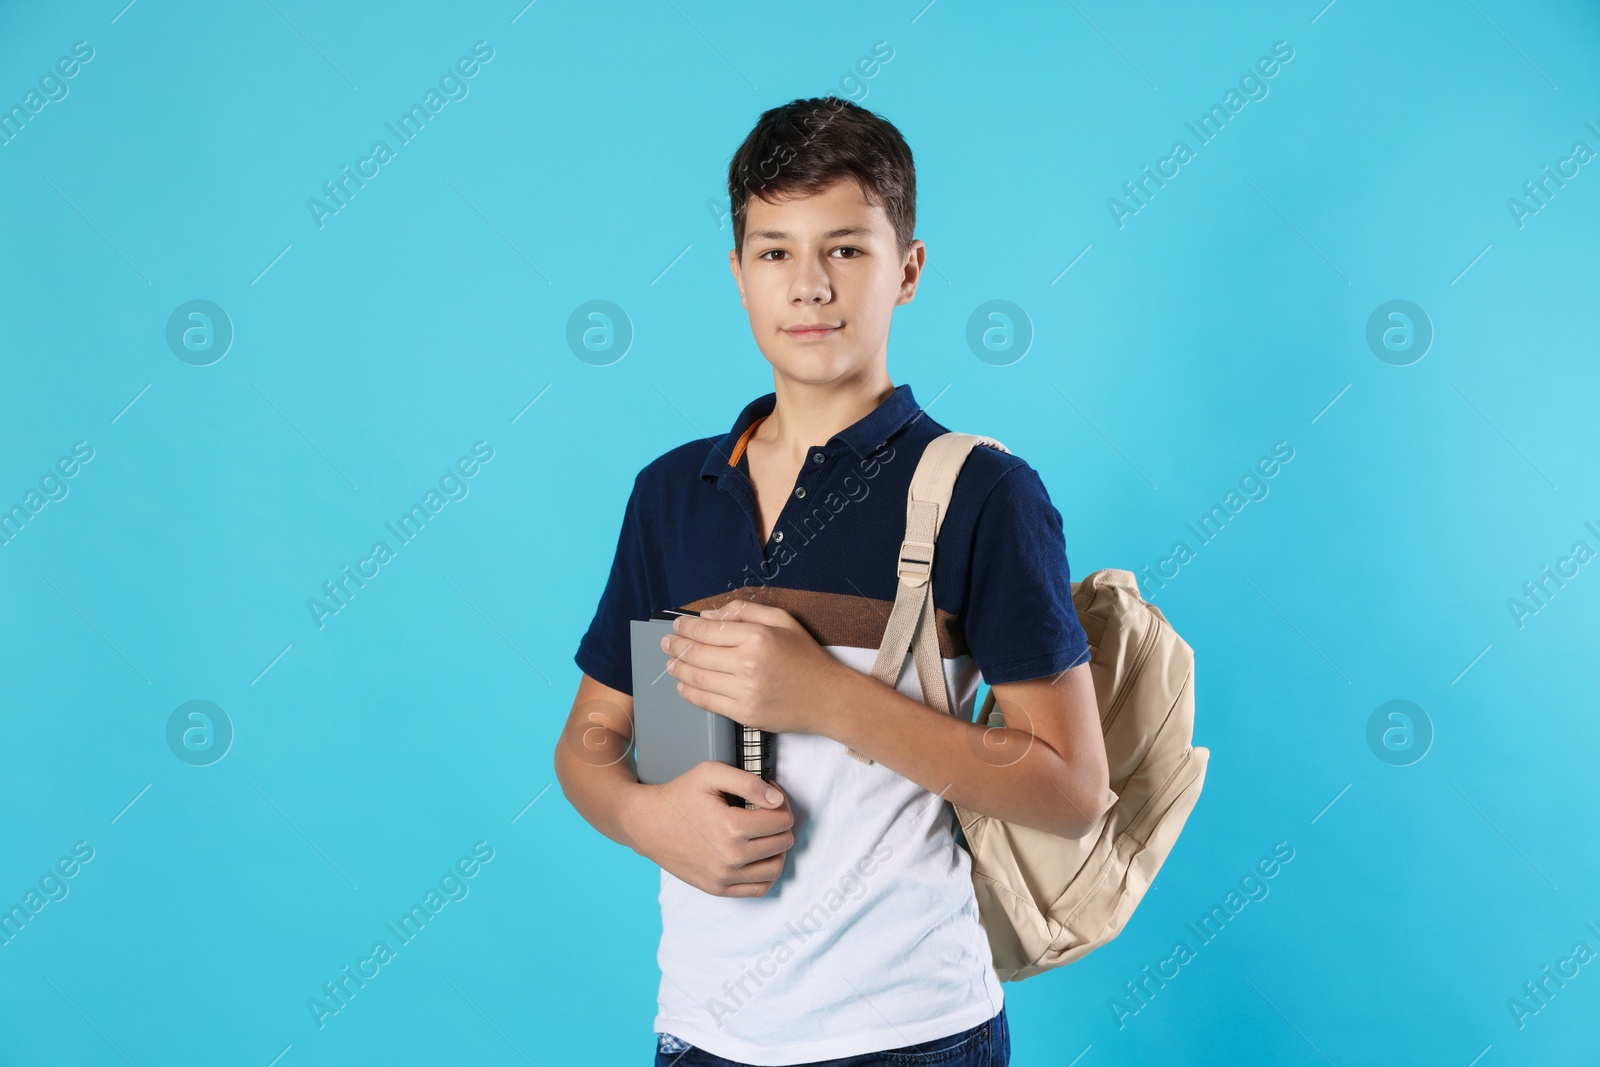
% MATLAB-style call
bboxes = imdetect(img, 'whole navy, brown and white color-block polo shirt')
[574,386,1088,1064]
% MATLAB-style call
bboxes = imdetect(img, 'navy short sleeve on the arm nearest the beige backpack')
[963,464,1090,685]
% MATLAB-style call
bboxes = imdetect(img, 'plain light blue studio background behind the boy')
[0,0,1600,1067]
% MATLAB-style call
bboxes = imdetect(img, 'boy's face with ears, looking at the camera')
[728,178,926,384]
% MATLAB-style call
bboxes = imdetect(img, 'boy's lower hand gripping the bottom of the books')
[629,760,795,896]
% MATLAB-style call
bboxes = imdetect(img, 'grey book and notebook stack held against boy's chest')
[629,608,776,809]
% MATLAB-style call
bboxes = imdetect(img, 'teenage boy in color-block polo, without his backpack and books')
[555,98,1109,1067]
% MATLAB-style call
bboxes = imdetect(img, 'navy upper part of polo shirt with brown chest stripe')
[574,384,1090,700]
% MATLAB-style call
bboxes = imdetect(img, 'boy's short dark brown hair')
[728,96,917,256]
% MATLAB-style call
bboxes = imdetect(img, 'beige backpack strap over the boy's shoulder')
[845,434,1010,763]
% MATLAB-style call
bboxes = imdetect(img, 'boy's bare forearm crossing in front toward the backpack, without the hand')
[821,664,1104,837]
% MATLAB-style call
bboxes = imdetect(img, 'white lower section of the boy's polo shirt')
[654,646,1005,1067]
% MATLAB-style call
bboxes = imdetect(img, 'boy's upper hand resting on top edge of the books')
[662,600,856,734]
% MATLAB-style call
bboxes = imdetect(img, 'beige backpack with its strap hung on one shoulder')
[850,434,1210,982]
